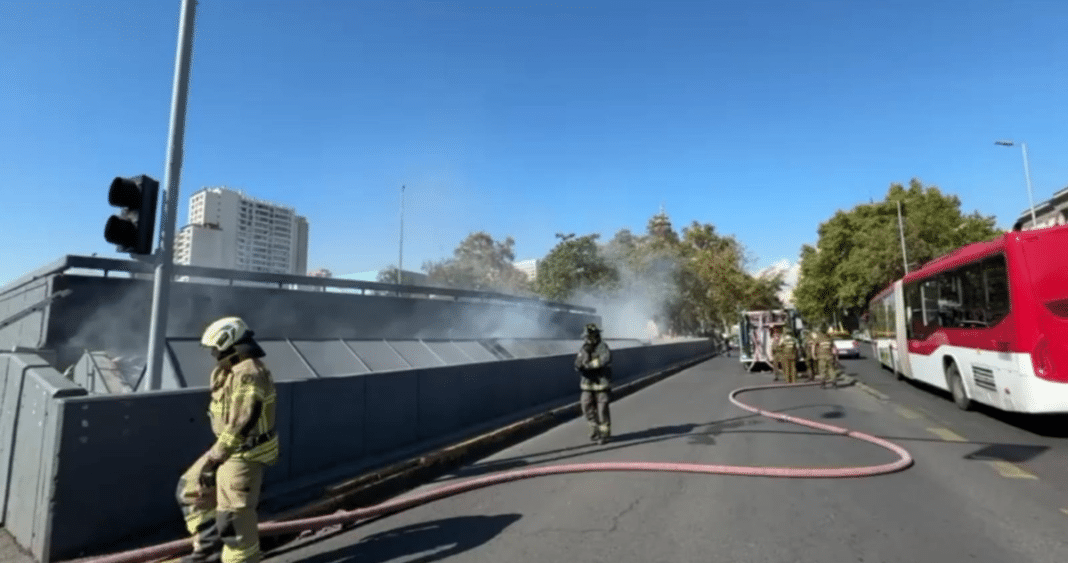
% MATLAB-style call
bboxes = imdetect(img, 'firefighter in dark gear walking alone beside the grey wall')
[575,323,612,443]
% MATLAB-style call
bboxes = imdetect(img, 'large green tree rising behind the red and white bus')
[794,178,1001,323]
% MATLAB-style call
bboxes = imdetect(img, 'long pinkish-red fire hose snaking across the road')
[71,382,913,563]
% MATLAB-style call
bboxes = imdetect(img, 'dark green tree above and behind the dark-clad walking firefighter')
[533,233,619,301]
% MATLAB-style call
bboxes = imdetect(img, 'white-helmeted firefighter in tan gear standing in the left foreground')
[177,316,279,563]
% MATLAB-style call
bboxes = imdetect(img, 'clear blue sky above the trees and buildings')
[0,0,1068,284]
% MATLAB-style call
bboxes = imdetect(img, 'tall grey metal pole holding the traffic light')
[148,0,197,390]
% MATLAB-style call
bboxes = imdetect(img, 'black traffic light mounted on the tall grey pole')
[104,174,159,254]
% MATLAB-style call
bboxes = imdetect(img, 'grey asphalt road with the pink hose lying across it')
[267,357,1068,563]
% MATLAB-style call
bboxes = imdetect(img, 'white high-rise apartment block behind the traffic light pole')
[174,187,309,276]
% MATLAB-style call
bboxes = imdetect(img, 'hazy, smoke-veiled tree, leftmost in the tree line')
[420,231,529,294]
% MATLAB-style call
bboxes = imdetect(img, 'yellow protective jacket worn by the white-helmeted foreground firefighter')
[208,358,279,465]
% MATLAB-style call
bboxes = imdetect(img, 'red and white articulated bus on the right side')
[868,225,1068,413]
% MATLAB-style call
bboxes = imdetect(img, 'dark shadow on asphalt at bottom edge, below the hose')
[279,514,522,563]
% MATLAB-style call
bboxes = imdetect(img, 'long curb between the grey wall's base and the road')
[271,353,718,521]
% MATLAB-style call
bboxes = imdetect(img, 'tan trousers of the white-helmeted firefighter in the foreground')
[177,454,264,563]
